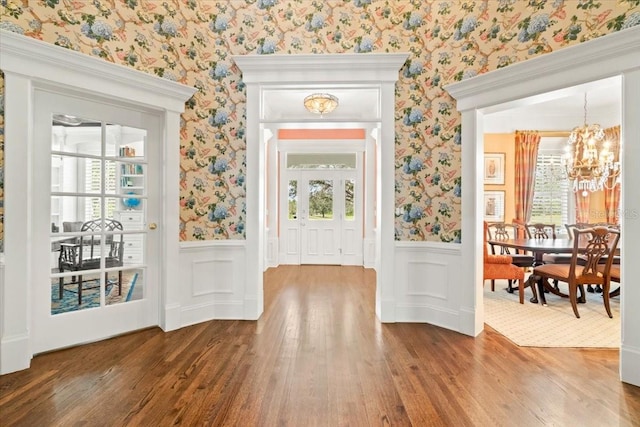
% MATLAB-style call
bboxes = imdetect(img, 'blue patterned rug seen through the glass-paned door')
[51,273,138,314]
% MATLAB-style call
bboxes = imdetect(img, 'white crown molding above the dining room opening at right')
[444,26,640,112]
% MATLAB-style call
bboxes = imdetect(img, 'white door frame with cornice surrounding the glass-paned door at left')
[0,30,196,374]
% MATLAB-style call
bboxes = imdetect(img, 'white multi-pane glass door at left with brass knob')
[25,90,162,353]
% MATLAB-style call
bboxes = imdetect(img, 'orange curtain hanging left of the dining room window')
[515,131,540,223]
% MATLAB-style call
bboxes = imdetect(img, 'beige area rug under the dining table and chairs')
[484,280,621,348]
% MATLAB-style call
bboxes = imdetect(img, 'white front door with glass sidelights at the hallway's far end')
[280,169,362,265]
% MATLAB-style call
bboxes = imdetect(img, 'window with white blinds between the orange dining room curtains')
[529,152,570,229]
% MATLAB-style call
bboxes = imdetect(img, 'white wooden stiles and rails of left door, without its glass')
[27,89,162,354]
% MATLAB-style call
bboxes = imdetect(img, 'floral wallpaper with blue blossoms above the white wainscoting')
[0,0,640,249]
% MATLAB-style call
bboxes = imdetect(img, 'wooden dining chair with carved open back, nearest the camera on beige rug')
[533,227,620,318]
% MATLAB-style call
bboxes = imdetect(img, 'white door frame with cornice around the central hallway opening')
[233,53,409,322]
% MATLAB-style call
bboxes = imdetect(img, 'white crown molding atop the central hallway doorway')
[232,52,409,84]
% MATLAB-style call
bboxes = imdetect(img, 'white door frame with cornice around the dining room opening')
[445,26,640,386]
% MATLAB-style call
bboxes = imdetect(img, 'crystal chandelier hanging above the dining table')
[562,93,620,196]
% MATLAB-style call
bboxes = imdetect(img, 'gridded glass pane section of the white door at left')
[51,120,147,315]
